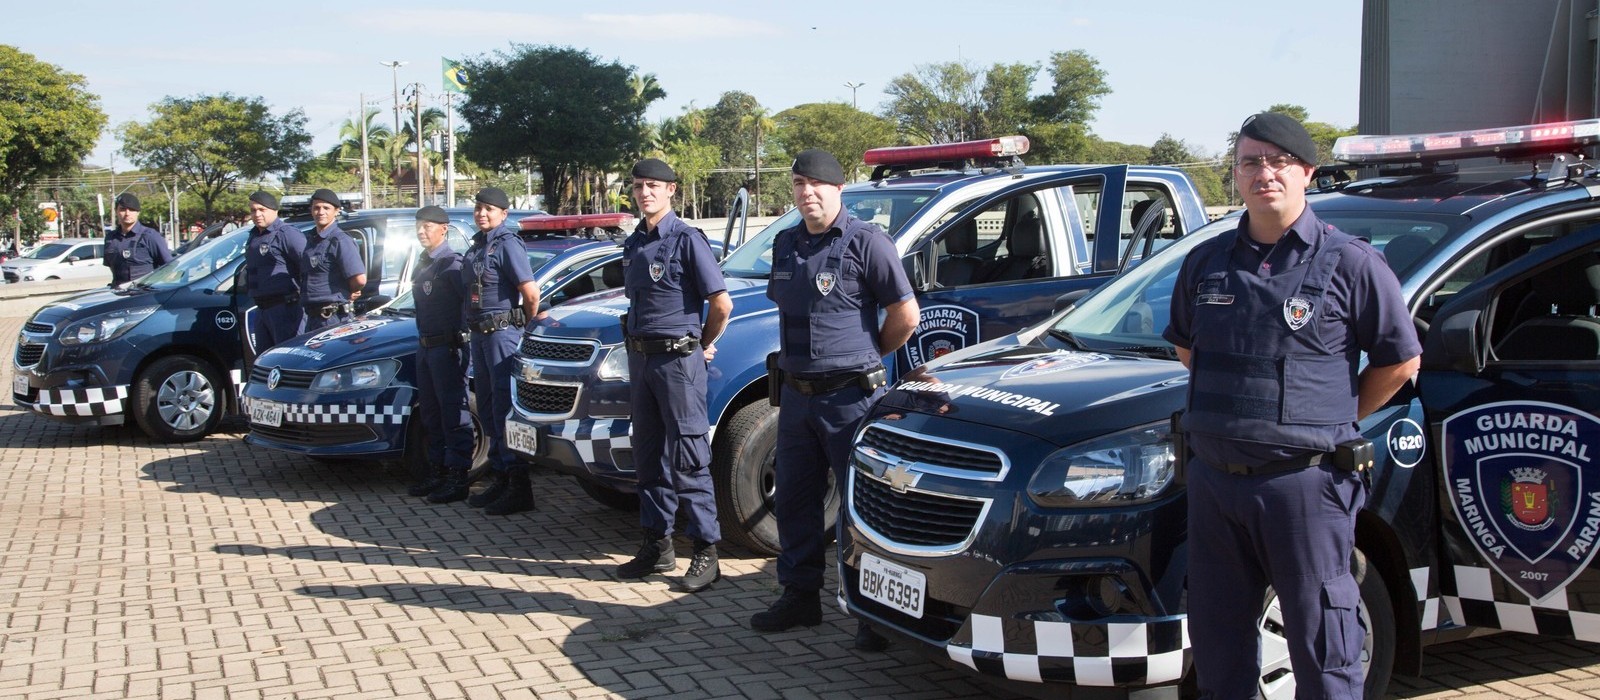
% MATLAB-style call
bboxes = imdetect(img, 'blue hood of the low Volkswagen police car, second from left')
[256,315,418,371]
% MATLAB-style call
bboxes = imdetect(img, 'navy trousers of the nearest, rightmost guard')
[1186,459,1376,700]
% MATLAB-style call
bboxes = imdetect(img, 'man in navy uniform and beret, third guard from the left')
[301,190,366,332]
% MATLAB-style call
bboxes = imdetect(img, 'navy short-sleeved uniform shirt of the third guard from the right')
[622,211,728,339]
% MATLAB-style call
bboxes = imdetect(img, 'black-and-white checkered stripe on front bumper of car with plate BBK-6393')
[946,614,1189,686]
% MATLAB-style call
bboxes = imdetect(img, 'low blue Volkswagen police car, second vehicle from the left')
[243,214,634,478]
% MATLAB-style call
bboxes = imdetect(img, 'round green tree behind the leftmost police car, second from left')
[118,93,310,221]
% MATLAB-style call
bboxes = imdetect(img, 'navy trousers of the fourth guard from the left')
[416,345,472,468]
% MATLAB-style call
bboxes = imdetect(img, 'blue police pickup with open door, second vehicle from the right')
[506,136,1206,553]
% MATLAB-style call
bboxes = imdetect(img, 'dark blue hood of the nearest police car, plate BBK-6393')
[880,336,1189,446]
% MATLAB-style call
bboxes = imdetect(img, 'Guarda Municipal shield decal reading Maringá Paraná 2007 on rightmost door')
[1440,401,1600,601]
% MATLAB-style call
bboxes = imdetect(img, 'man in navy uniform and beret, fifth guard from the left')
[461,187,539,515]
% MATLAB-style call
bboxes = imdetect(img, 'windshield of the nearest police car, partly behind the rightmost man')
[1051,211,1466,350]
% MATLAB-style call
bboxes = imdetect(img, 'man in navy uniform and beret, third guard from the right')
[616,158,733,591]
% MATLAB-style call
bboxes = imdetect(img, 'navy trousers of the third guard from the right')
[627,348,722,543]
